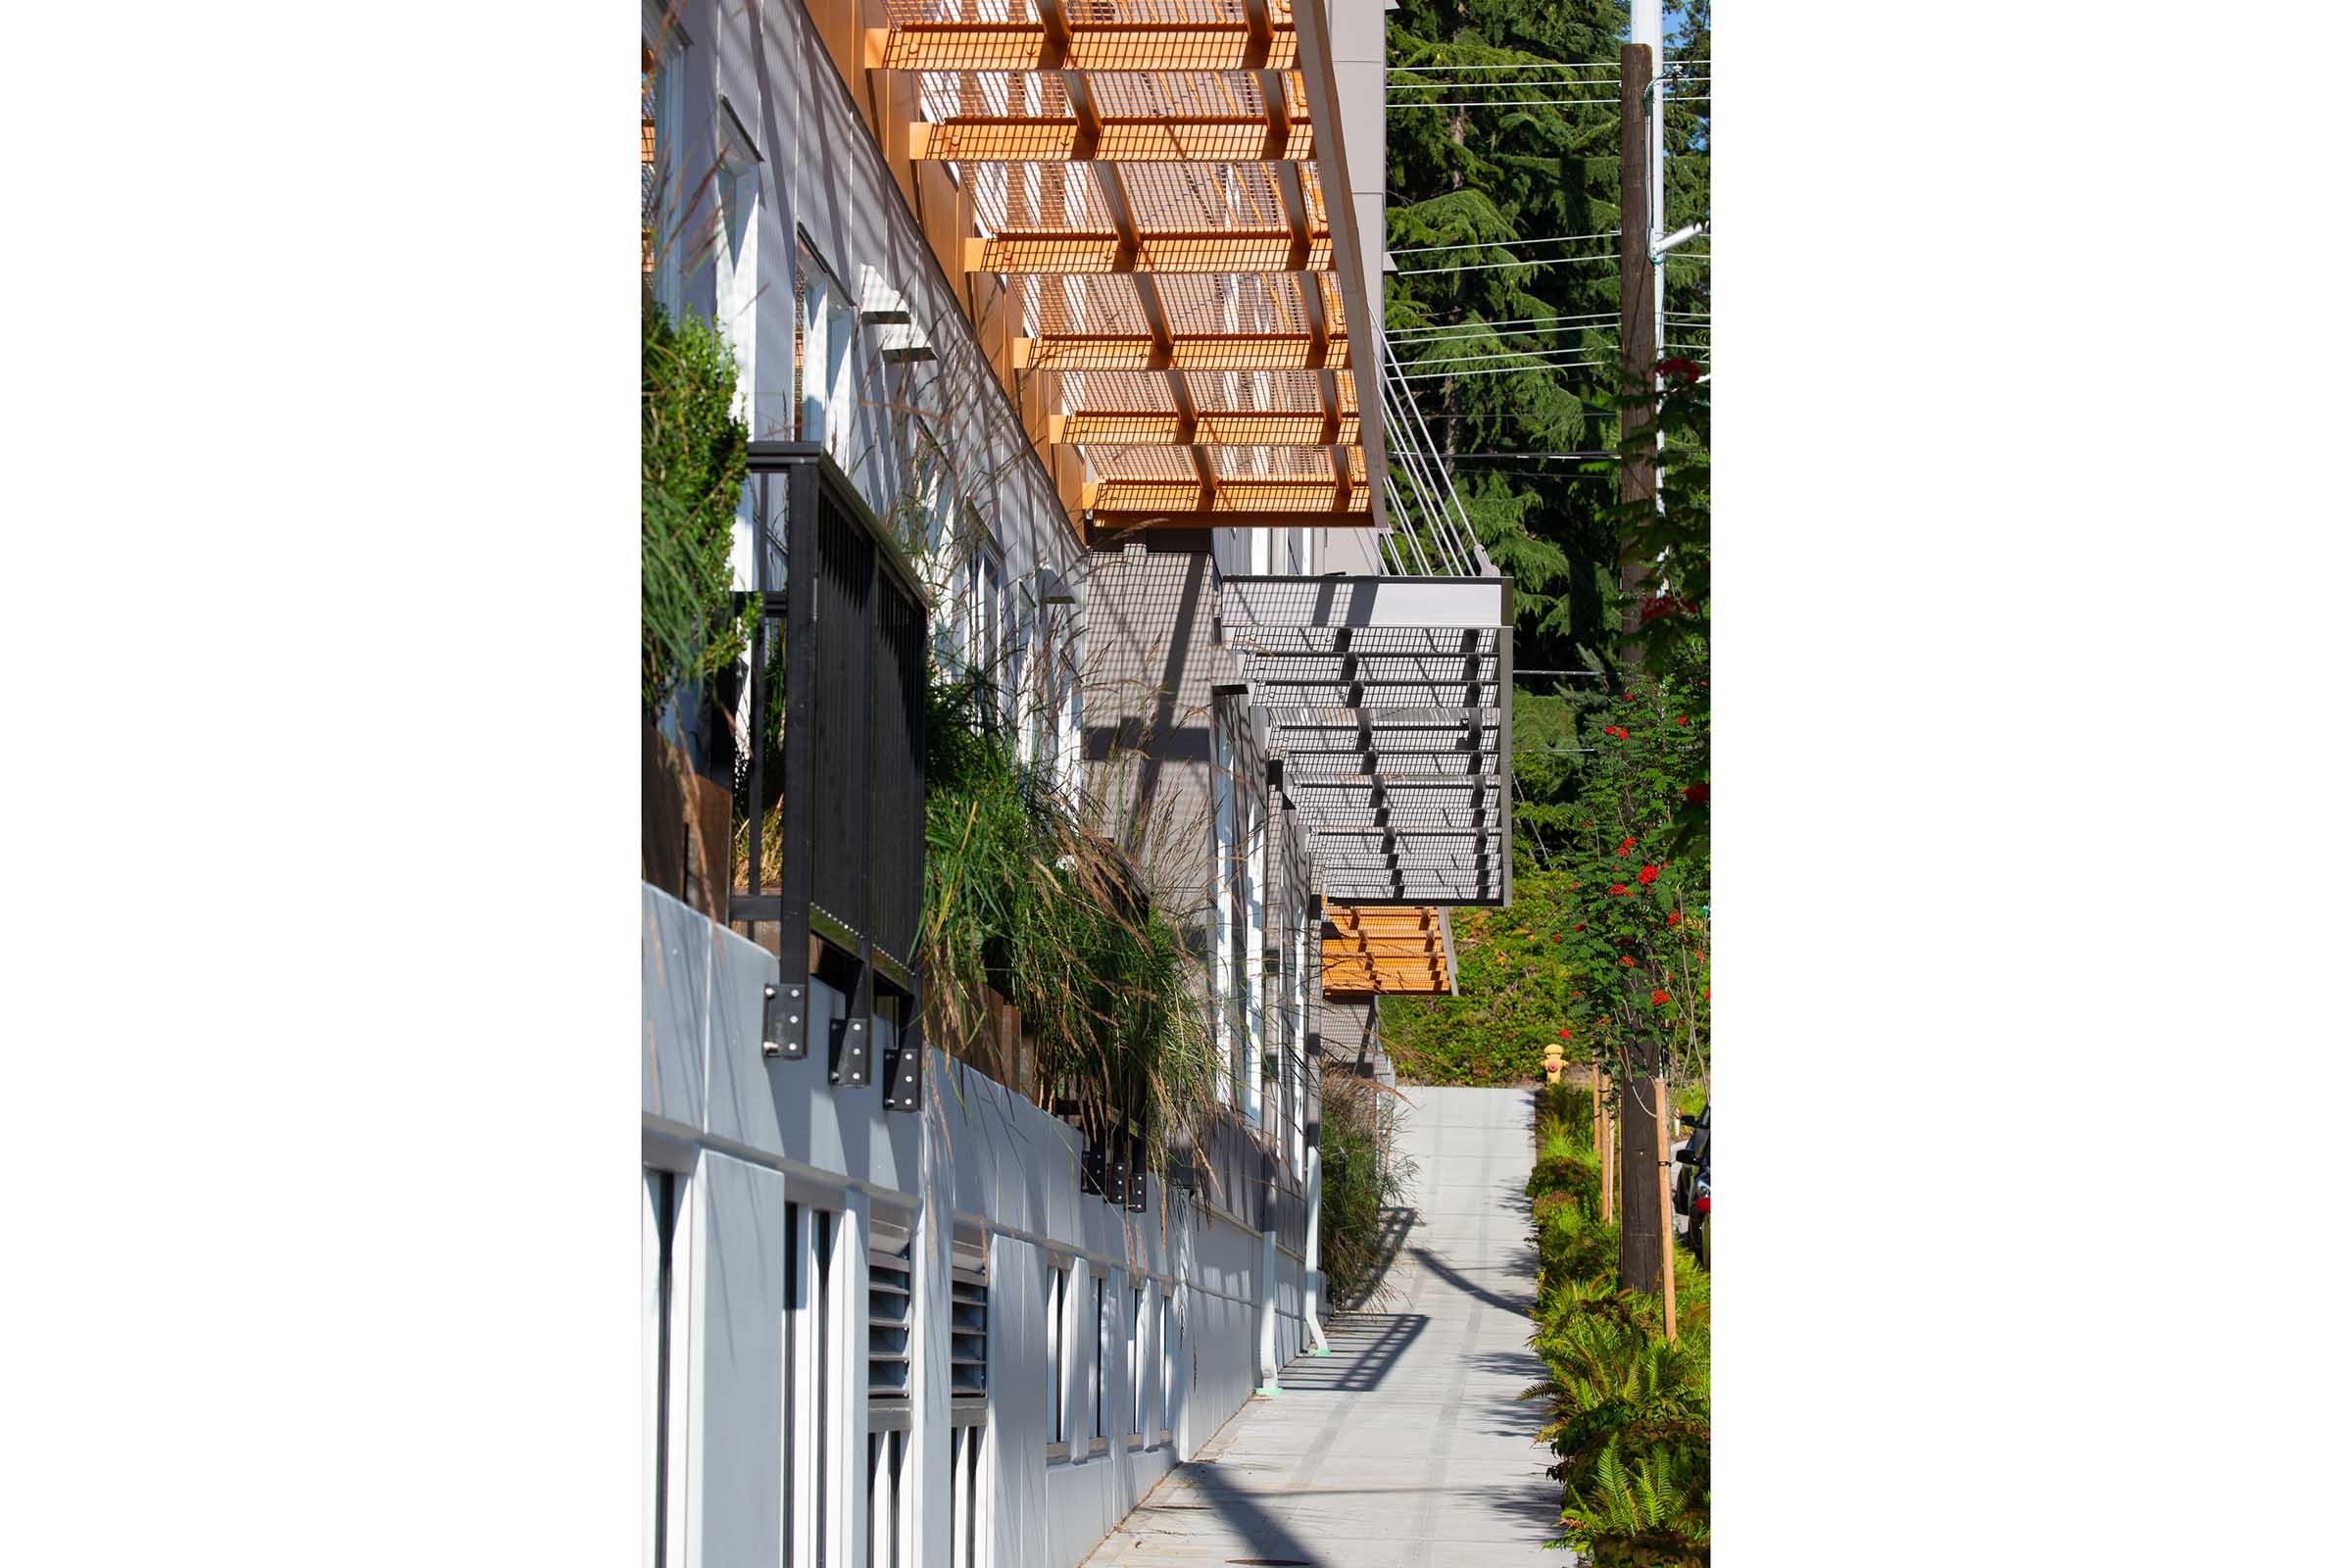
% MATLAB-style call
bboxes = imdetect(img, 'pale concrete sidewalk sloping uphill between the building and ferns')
[1087,1089,1576,1568]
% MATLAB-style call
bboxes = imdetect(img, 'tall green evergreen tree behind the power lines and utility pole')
[1386,0,1710,870]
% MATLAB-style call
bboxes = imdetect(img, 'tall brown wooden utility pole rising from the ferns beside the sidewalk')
[1616,21,1668,1296]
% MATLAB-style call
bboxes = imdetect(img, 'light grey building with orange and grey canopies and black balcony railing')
[640,0,1510,1568]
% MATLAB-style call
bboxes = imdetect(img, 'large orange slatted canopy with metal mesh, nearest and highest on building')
[865,0,1378,534]
